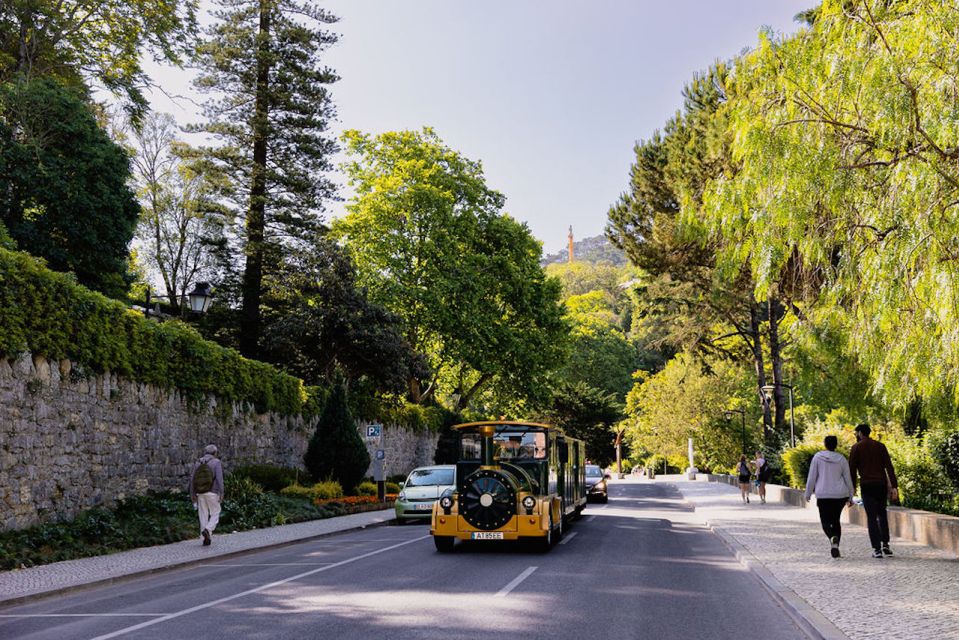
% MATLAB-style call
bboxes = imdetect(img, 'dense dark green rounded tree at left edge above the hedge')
[0,79,140,296]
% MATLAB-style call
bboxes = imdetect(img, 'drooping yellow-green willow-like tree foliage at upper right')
[704,0,959,404]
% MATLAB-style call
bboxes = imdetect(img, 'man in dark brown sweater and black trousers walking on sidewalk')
[849,424,899,558]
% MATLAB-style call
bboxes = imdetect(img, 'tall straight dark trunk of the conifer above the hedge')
[240,0,273,358]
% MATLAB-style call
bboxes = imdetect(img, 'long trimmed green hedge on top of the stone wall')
[0,249,314,415]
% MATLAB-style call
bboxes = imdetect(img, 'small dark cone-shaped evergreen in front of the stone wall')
[303,378,370,493]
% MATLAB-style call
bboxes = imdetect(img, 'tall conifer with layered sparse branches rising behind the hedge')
[195,0,338,357]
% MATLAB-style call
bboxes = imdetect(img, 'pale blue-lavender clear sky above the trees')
[153,0,816,253]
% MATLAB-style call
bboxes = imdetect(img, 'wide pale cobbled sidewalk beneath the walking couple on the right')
[668,476,959,640]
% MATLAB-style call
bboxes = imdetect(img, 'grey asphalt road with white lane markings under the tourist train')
[0,483,807,640]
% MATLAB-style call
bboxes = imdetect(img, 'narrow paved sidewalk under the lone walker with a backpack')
[0,509,394,606]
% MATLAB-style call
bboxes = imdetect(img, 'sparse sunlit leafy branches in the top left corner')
[0,0,197,117]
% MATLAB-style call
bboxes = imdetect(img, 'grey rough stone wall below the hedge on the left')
[0,355,436,529]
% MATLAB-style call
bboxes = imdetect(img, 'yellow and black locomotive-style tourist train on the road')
[430,420,586,552]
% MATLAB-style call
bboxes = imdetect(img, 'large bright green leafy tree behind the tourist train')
[333,129,565,410]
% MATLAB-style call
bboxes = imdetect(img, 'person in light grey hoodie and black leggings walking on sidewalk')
[806,436,853,558]
